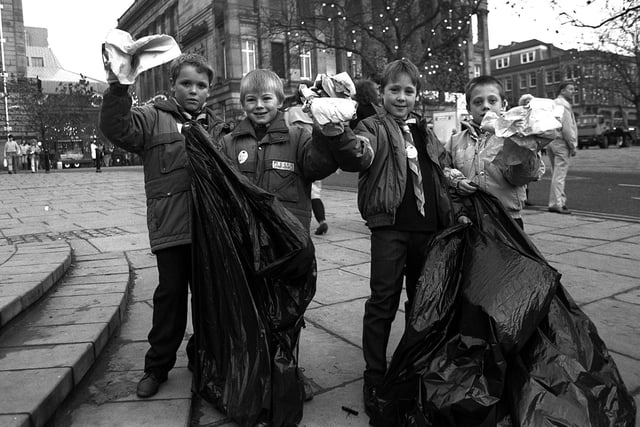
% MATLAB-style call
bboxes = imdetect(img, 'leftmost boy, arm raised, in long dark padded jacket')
[100,54,222,397]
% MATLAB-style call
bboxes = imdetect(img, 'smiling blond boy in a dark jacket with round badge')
[222,69,372,412]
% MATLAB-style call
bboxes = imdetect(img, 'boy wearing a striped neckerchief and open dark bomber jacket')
[328,59,468,419]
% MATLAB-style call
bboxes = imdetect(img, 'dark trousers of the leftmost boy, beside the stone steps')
[144,245,191,378]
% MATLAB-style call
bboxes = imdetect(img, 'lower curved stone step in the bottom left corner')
[0,249,131,427]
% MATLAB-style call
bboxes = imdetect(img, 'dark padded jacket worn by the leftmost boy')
[100,83,221,252]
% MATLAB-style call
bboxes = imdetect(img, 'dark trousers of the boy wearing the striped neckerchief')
[362,229,433,387]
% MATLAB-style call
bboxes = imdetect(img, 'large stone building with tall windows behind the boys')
[118,0,489,120]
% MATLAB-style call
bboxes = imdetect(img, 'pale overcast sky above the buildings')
[22,0,604,80]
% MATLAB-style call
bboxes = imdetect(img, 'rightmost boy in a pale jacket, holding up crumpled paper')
[445,76,544,229]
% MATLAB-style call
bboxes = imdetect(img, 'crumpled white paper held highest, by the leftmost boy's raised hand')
[104,29,182,85]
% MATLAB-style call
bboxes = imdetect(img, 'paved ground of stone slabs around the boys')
[0,166,640,426]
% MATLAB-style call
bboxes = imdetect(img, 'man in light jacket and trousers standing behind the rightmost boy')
[547,81,578,215]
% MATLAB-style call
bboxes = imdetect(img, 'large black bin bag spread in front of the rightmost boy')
[372,192,636,427]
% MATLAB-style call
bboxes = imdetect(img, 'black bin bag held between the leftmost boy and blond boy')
[182,124,316,426]
